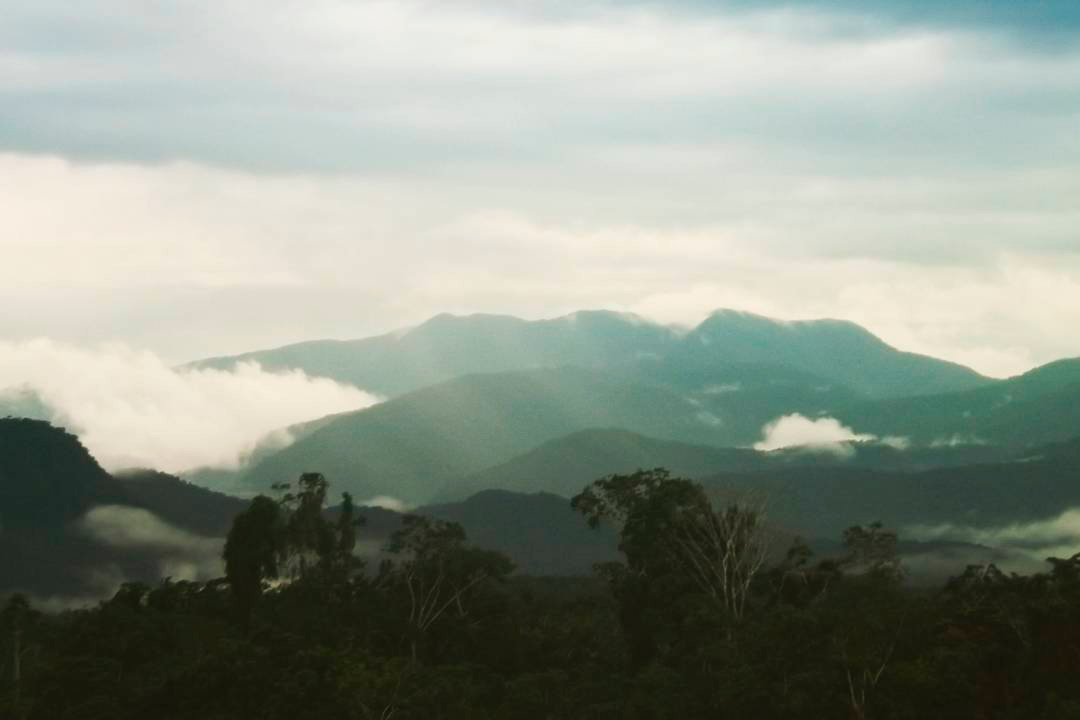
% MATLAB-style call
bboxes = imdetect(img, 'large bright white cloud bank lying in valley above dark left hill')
[0,340,376,472]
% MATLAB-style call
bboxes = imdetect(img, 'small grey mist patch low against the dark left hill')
[79,505,225,581]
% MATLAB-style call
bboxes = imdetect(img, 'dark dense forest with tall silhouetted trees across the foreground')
[0,470,1080,720]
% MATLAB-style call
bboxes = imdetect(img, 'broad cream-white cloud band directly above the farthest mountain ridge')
[0,154,1080,375]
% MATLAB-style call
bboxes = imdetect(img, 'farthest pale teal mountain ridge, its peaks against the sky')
[191,310,989,397]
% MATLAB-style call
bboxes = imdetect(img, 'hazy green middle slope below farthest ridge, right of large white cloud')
[232,368,724,504]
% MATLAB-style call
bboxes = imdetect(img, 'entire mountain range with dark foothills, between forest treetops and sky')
[0,311,1080,593]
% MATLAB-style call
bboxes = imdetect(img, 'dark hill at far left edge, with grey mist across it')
[0,418,245,600]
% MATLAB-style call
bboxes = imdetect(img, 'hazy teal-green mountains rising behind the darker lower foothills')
[187,311,1080,505]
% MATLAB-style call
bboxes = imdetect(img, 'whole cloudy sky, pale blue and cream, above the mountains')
[0,0,1080,376]
